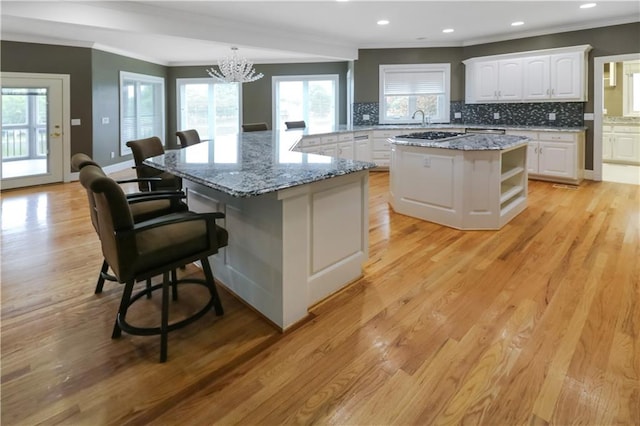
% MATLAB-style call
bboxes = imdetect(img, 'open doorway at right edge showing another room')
[593,53,640,185]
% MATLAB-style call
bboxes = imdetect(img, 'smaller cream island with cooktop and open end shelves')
[389,133,527,230]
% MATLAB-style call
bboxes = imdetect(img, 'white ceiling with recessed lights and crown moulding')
[0,0,640,66]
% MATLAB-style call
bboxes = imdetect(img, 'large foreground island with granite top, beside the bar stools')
[145,131,375,330]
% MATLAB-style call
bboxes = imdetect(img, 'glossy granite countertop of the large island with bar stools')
[144,131,376,197]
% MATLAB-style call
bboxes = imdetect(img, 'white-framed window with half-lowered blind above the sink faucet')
[379,64,451,124]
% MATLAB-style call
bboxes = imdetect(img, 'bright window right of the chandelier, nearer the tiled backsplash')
[272,74,338,130]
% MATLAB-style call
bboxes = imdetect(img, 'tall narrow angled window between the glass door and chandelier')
[120,71,165,155]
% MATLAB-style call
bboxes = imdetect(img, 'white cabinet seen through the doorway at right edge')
[602,125,640,165]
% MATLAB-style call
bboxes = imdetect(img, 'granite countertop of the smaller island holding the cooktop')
[389,134,529,151]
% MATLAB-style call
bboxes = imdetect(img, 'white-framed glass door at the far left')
[0,73,70,189]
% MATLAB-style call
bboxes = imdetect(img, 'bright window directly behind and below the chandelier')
[177,78,242,139]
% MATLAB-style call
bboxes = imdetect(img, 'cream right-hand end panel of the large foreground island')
[279,171,369,310]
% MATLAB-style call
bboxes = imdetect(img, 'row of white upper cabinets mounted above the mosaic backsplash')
[464,45,591,103]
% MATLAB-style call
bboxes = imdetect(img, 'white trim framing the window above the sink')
[378,63,451,124]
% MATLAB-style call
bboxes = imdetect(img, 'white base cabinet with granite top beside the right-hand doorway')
[507,131,584,184]
